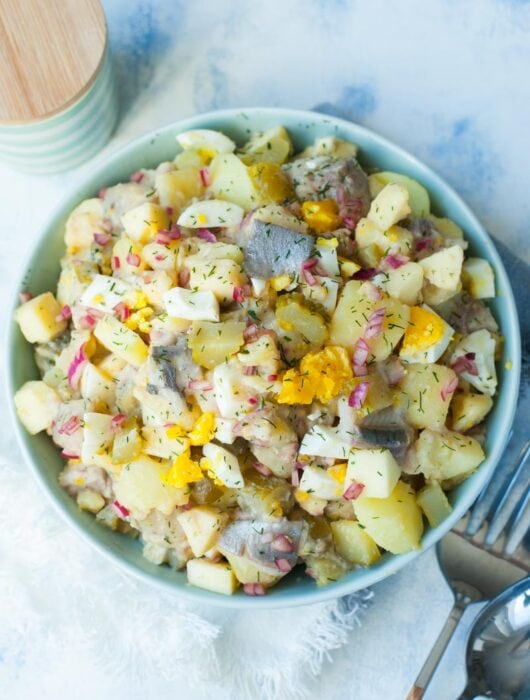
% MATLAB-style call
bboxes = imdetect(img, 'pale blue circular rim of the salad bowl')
[4,107,521,609]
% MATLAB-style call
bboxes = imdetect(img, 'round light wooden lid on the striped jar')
[0,0,107,125]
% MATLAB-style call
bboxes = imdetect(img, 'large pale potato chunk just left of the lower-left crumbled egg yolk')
[114,456,189,517]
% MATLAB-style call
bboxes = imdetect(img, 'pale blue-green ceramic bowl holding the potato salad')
[7,108,520,608]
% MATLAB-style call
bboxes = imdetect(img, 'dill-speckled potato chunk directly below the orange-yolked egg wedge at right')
[399,363,456,430]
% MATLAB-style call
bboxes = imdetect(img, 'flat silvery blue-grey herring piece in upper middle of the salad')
[244,219,315,279]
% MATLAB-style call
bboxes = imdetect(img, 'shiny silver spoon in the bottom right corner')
[461,577,530,700]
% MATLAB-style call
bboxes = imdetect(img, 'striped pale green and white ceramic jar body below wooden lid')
[0,46,118,175]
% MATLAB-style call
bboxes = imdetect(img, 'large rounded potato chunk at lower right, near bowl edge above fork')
[415,430,484,485]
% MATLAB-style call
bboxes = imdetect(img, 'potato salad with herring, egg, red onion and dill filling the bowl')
[15,119,502,596]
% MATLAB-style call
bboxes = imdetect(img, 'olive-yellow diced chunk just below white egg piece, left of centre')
[188,321,245,369]
